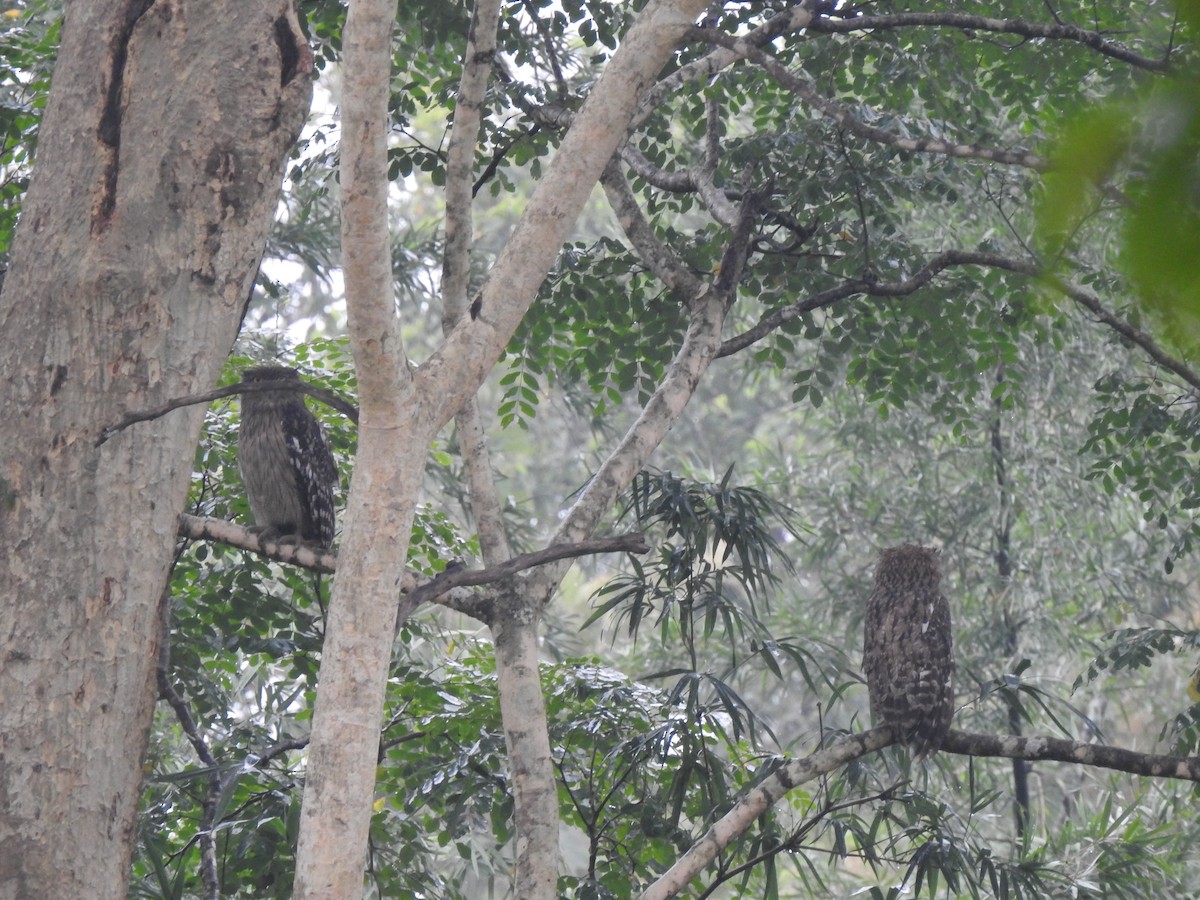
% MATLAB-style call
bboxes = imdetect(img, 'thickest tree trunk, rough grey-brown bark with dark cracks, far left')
[0,0,311,898]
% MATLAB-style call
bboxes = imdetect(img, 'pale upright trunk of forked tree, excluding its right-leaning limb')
[293,0,403,900]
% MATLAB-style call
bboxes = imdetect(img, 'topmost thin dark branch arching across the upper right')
[808,12,1169,72]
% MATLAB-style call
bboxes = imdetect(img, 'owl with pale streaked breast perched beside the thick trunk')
[238,366,337,547]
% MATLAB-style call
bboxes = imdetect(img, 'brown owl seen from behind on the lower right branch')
[863,544,954,761]
